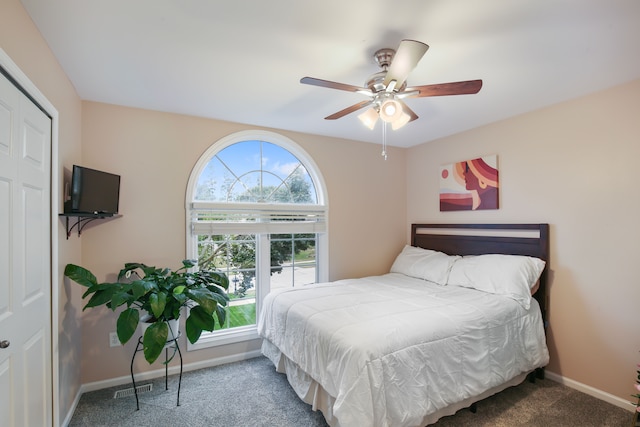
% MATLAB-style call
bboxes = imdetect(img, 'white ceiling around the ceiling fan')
[21,0,640,147]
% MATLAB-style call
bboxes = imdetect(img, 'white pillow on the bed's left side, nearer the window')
[391,245,460,285]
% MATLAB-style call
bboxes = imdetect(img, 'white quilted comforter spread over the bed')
[258,273,549,427]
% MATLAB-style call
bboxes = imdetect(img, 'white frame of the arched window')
[185,130,329,351]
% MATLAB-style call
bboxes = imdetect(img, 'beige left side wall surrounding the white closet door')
[0,0,82,419]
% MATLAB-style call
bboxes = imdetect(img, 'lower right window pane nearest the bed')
[270,234,316,290]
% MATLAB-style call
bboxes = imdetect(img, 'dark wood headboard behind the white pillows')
[411,224,549,322]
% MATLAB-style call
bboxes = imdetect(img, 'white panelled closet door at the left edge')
[0,74,53,427]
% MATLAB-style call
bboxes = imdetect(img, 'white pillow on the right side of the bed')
[447,254,545,310]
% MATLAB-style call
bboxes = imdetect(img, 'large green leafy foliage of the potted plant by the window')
[64,260,229,363]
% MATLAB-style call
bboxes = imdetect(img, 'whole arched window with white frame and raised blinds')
[186,131,328,349]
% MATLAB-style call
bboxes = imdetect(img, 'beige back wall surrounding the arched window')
[79,102,406,383]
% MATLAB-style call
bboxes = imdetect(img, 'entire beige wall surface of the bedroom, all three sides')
[0,0,640,417]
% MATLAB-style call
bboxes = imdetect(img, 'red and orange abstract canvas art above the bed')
[440,155,499,212]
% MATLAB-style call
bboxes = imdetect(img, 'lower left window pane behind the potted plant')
[198,235,256,329]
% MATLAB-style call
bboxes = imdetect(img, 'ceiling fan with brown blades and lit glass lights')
[300,40,482,130]
